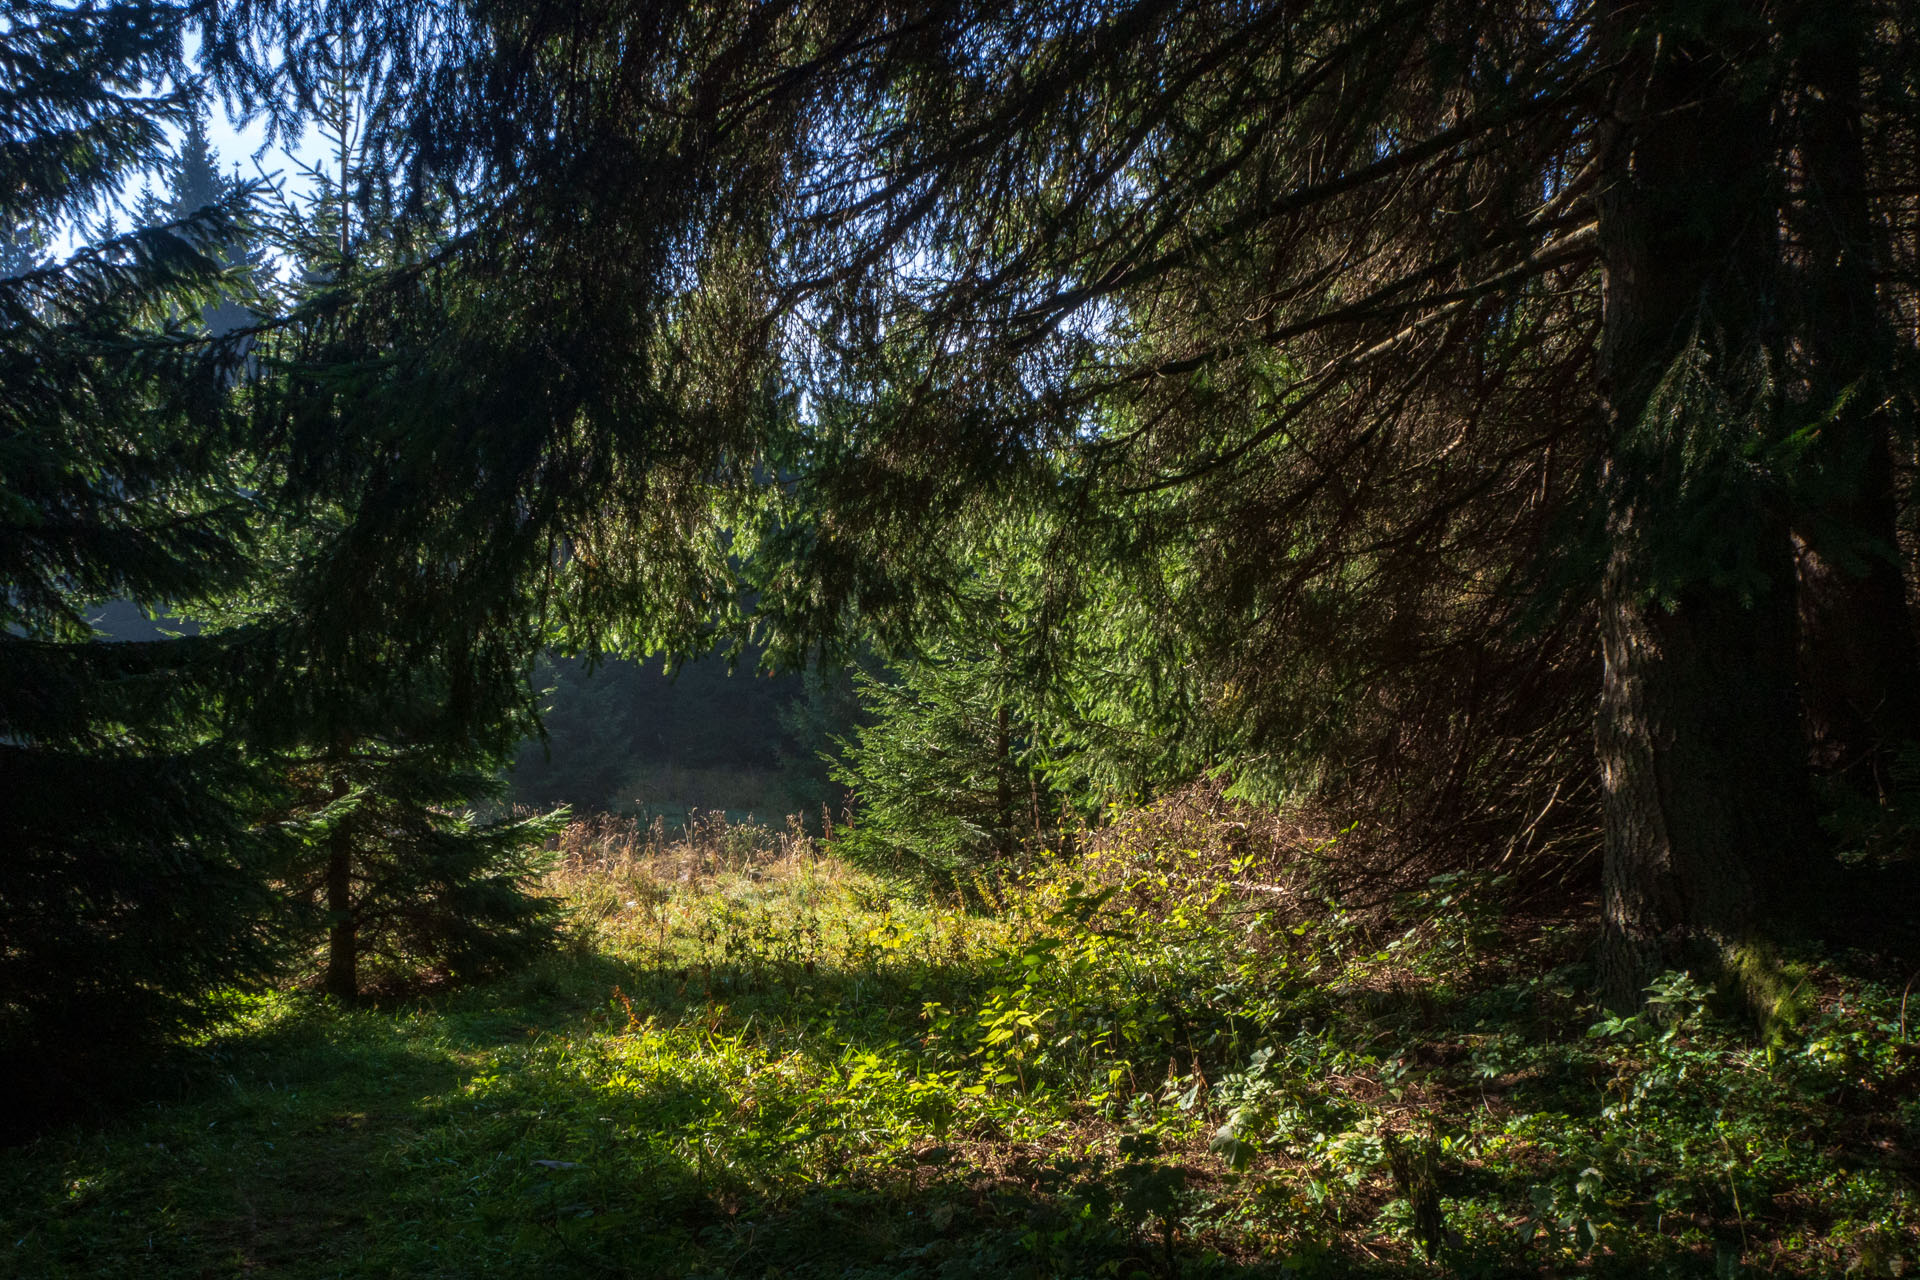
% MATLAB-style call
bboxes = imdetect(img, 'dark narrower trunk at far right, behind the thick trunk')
[1795,0,1920,775]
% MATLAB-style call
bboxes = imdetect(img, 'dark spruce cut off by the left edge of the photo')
[0,4,280,1119]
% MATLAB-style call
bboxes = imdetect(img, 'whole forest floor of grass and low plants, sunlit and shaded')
[0,825,1920,1278]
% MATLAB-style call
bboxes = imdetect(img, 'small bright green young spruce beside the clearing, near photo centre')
[810,509,1198,896]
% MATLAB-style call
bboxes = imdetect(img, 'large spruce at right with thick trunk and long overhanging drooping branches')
[198,0,1920,998]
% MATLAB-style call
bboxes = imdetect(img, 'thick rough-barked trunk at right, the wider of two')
[1596,0,1811,1007]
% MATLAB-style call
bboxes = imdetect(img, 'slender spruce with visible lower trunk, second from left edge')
[228,8,564,1000]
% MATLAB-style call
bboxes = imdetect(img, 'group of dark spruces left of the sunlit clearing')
[0,4,557,1128]
